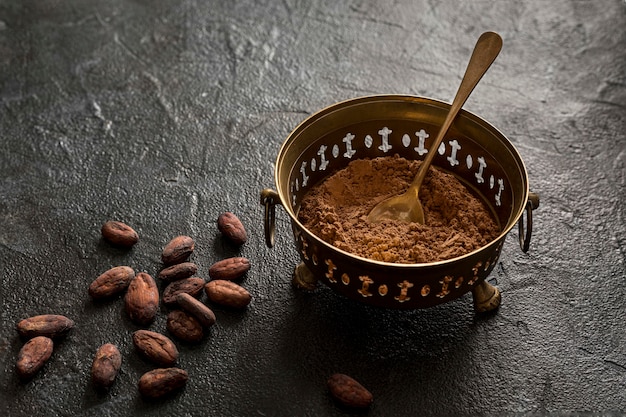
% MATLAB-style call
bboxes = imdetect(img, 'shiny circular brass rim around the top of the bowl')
[274,94,530,270]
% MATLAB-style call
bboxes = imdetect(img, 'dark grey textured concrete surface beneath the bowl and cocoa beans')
[0,0,626,416]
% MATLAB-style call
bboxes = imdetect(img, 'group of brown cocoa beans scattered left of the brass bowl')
[16,212,252,398]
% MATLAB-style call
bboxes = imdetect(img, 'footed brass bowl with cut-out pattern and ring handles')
[261,95,539,312]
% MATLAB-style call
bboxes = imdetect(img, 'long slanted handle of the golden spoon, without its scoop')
[410,32,502,192]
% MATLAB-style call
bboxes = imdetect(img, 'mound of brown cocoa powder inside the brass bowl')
[298,155,500,264]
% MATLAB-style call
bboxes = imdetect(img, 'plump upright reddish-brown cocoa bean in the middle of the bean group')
[124,272,159,326]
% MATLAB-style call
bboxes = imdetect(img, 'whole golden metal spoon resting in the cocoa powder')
[367,32,502,224]
